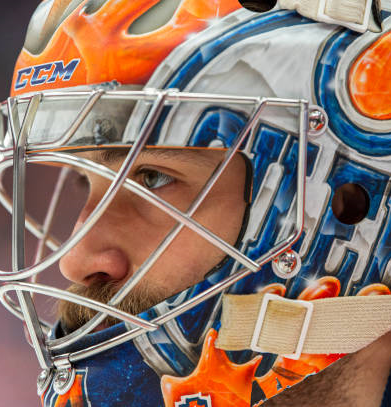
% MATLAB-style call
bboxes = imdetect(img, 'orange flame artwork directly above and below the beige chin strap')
[161,276,390,407]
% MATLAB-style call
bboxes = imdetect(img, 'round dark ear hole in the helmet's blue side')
[331,183,370,225]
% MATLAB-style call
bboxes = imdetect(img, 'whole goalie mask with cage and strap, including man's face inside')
[0,0,391,407]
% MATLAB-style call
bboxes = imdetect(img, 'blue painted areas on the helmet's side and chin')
[46,11,391,407]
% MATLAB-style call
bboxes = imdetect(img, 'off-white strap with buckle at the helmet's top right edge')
[278,0,381,32]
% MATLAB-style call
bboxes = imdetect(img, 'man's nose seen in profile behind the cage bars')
[60,207,130,286]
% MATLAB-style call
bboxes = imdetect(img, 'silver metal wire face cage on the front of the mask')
[0,89,309,381]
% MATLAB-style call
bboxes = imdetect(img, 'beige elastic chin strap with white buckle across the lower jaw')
[216,293,391,359]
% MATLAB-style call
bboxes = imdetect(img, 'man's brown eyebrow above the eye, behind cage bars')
[93,148,217,168]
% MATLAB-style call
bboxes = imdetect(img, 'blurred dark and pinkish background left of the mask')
[0,0,56,407]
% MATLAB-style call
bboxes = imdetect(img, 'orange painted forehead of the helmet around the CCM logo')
[11,0,241,95]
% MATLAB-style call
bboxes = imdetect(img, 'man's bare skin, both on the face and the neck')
[60,150,391,407]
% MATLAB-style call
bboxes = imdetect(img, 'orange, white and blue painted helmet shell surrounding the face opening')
[3,0,391,407]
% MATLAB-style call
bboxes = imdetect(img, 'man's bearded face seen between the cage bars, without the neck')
[59,149,246,330]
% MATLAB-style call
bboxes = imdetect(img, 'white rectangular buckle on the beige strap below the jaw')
[250,293,314,360]
